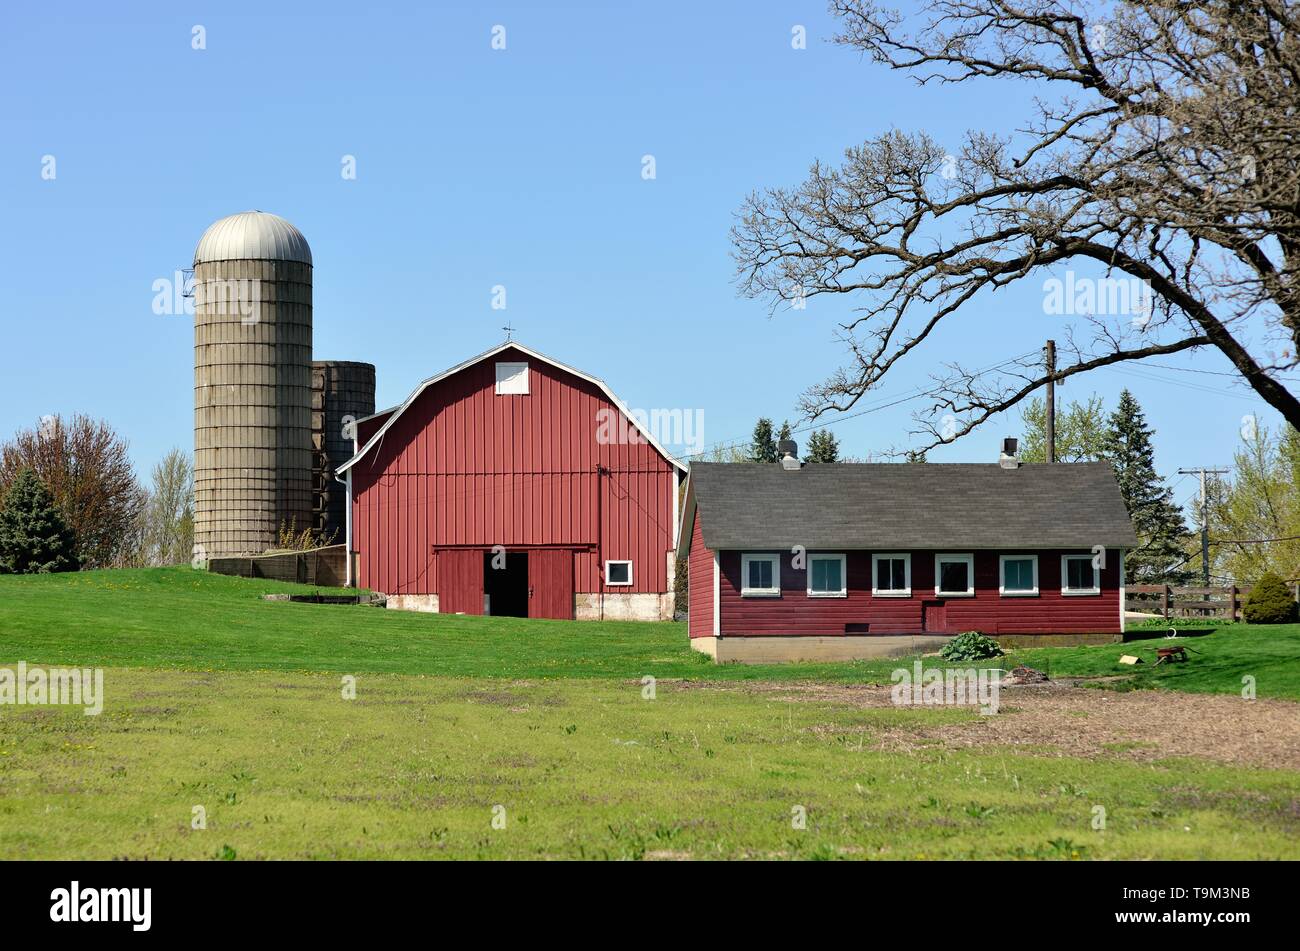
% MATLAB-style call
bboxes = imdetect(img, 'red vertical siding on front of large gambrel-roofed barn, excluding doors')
[351,349,676,594]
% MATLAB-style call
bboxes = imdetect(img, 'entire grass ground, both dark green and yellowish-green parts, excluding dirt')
[0,568,1300,859]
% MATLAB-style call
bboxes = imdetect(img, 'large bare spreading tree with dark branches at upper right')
[732,0,1300,448]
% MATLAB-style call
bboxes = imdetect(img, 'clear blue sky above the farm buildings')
[0,0,1277,511]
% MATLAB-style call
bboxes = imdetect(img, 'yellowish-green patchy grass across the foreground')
[0,669,1300,859]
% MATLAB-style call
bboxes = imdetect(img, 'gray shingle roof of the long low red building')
[686,463,1138,551]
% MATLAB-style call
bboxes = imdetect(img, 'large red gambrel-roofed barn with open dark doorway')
[339,343,685,620]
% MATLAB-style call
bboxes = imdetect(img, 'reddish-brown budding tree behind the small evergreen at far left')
[0,414,144,568]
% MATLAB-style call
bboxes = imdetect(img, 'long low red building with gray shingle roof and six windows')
[677,457,1138,661]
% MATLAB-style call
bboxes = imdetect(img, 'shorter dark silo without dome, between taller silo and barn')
[312,360,374,544]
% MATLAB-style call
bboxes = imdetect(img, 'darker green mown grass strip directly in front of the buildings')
[0,568,1300,699]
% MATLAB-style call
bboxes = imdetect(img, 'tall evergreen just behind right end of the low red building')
[1104,390,1190,585]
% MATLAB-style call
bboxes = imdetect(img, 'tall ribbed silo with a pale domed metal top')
[194,212,312,559]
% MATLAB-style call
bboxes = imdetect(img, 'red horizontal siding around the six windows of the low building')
[717,545,1121,637]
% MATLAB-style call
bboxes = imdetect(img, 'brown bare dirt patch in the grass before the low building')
[675,682,1300,769]
